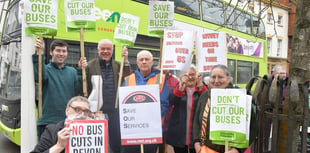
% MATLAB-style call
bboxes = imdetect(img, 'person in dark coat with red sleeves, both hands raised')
[167,65,207,153]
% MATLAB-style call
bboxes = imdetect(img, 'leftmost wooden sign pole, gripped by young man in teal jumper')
[37,37,43,118]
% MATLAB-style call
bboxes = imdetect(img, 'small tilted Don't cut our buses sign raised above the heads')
[114,13,140,47]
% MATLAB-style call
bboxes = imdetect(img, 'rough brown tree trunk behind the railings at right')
[277,0,310,153]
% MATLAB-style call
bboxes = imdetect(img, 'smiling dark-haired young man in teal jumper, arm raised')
[32,37,86,138]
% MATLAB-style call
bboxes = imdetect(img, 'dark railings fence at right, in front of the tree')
[246,75,310,153]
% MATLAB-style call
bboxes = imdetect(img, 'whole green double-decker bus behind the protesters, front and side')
[0,0,267,144]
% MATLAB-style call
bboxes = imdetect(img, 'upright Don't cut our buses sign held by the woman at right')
[210,89,247,142]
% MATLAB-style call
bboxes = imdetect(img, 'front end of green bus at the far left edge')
[0,0,21,145]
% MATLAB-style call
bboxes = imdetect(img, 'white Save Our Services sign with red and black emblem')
[119,84,162,145]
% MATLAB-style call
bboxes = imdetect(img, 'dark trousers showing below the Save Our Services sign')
[121,144,158,153]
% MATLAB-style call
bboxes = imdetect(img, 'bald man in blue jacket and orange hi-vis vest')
[121,50,169,153]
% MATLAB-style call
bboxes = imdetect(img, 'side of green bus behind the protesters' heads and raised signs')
[47,0,267,87]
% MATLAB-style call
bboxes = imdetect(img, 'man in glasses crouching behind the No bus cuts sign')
[31,96,93,153]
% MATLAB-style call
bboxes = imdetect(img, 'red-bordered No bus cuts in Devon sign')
[66,120,108,153]
